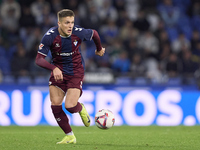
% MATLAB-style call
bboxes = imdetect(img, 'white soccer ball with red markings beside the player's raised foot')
[95,109,115,129]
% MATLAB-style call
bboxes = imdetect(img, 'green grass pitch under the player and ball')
[0,126,200,150]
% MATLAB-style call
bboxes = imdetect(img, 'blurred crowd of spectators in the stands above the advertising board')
[0,0,200,84]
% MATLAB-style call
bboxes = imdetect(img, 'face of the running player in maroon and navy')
[58,16,74,36]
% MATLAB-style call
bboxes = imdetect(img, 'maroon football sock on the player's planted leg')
[51,105,72,134]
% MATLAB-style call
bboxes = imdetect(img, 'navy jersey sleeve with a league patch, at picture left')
[38,34,52,56]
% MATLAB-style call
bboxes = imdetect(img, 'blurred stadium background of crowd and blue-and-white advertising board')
[0,0,200,125]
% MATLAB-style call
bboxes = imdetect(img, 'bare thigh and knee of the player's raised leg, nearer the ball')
[65,88,81,108]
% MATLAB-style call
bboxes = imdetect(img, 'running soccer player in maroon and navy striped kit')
[35,9,105,144]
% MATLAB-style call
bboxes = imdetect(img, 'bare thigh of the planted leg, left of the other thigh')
[49,85,65,105]
